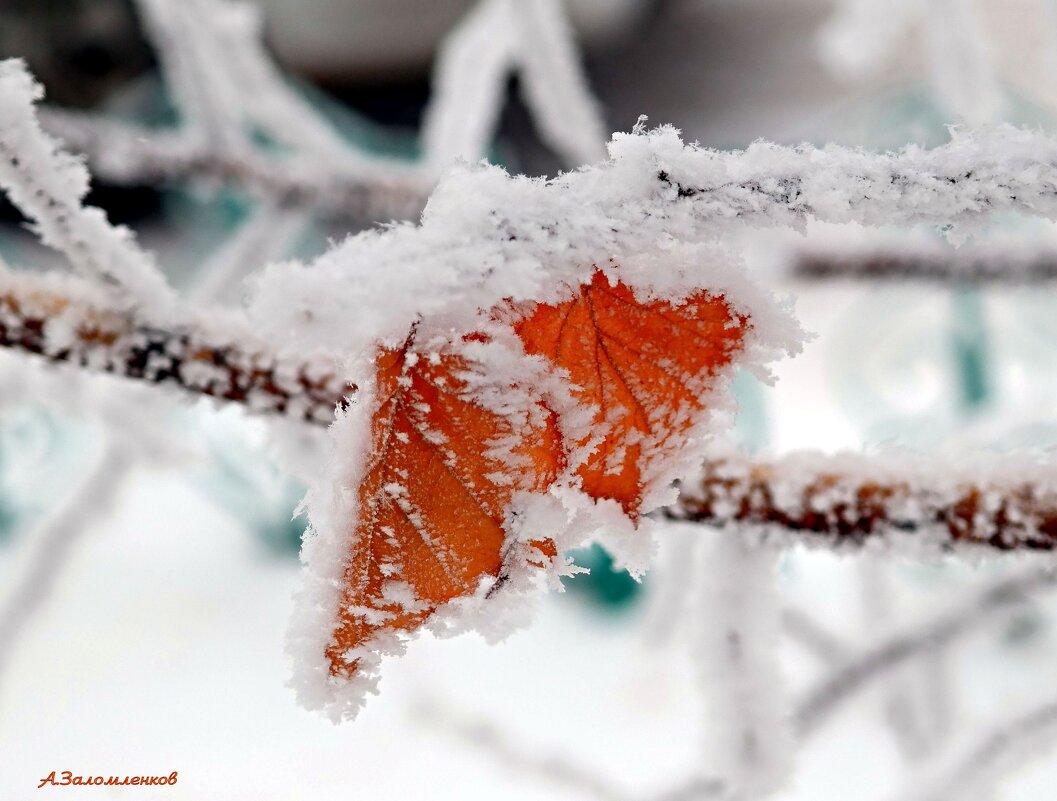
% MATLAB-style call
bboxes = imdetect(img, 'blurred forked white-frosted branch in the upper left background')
[35,0,434,222]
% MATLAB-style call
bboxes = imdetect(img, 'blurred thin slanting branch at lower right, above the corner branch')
[796,566,1057,735]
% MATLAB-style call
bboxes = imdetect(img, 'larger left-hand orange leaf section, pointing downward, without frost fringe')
[327,335,562,677]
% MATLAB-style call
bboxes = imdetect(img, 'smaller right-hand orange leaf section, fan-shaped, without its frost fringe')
[514,271,749,519]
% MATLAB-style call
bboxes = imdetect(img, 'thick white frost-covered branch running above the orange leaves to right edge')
[252,127,1057,357]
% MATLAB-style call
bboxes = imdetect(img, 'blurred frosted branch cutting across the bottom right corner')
[897,700,1057,801]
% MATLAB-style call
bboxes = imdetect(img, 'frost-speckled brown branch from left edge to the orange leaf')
[0,273,355,425]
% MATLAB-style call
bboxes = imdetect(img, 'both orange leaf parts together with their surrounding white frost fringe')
[290,247,799,720]
